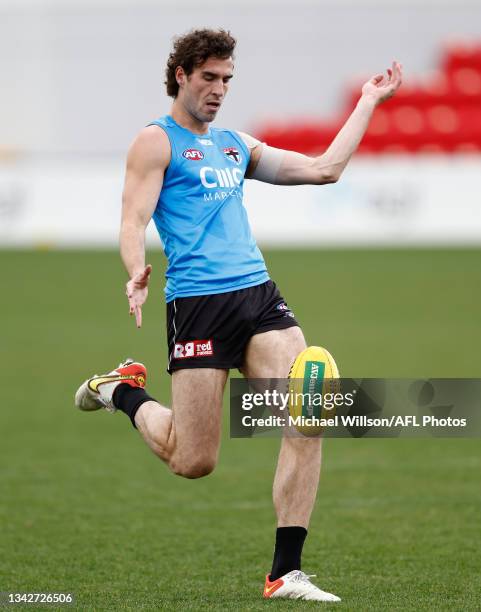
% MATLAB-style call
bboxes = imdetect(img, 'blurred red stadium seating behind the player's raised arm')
[255,42,481,154]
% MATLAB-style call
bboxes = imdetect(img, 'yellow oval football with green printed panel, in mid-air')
[289,346,340,436]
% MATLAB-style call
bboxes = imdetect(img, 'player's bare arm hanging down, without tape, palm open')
[120,126,170,327]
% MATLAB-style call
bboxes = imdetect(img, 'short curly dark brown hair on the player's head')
[165,29,237,98]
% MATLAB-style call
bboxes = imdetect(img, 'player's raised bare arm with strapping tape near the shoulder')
[242,62,402,185]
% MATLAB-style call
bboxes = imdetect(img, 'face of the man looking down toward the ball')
[177,57,234,123]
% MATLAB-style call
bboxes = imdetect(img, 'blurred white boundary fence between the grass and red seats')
[0,156,481,247]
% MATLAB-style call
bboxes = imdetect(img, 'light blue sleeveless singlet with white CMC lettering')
[150,116,269,302]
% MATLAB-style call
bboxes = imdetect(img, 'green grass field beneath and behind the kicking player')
[0,250,481,611]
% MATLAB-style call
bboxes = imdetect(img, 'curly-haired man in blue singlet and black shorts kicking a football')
[75,30,401,602]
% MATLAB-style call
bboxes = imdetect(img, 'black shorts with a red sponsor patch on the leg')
[167,280,299,374]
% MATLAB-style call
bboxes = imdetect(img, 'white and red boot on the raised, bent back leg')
[75,359,147,412]
